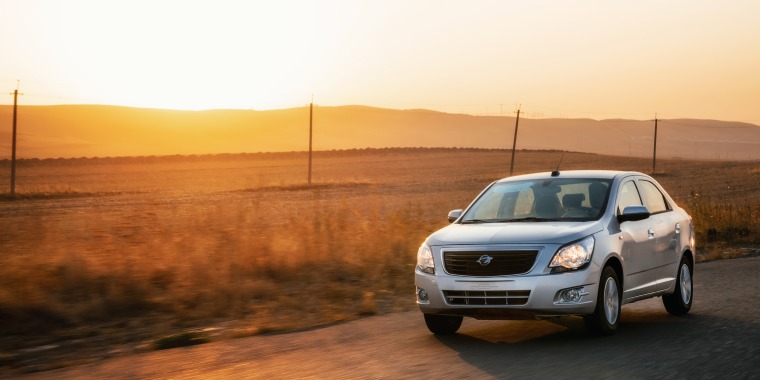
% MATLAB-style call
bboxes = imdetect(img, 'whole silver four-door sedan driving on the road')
[415,171,695,335]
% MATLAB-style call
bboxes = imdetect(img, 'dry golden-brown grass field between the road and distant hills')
[0,149,760,373]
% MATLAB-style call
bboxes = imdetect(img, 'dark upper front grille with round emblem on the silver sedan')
[443,251,538,276]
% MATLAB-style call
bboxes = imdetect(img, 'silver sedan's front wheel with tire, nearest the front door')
[583,266,622,335]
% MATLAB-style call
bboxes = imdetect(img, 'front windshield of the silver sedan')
[462,178,611,223]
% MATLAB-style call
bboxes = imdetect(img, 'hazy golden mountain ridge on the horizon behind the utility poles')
[0,105,760,160]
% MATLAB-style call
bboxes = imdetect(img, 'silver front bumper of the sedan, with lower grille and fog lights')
[415,266,599,319]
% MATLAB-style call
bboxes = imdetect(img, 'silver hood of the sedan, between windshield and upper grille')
[427,221,602,246]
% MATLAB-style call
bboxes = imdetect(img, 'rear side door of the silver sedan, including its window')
[638,179,688,290]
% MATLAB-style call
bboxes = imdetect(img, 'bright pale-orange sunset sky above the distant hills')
[0,0,760,124]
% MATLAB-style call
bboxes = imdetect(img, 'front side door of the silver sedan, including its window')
[616,178,659,299]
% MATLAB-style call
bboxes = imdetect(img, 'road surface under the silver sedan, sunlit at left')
[16,257,760,379]
